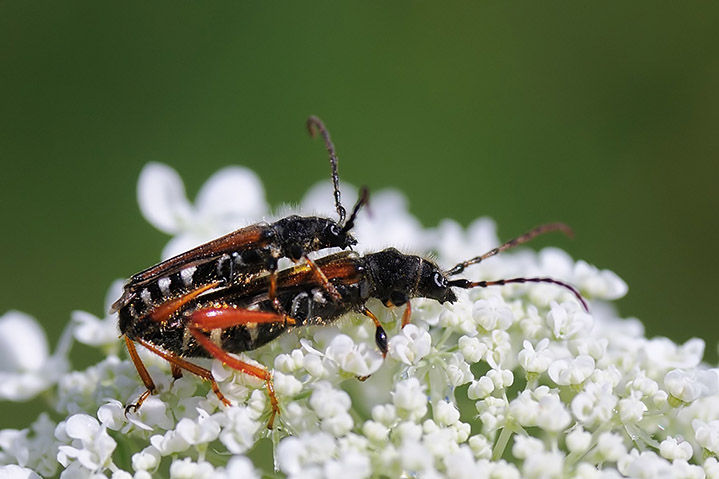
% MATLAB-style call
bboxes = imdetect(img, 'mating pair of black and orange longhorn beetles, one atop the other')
[113,117,586,428]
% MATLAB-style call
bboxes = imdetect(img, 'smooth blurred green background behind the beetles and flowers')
[0,1,719,427]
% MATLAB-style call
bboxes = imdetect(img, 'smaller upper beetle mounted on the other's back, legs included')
[117,116,368,420]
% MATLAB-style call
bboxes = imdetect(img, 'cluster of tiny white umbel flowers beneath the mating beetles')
[0,164,719,479]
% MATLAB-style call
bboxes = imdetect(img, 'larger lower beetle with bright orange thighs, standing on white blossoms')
[126,223,587,428]
